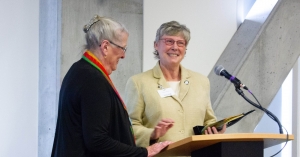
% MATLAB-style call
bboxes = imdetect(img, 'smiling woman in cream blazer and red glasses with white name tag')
[125,21,226,147]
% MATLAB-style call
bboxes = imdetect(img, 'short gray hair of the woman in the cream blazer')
[153,21,191,59]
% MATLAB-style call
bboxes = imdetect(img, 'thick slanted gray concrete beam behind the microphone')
[209,0,300,133]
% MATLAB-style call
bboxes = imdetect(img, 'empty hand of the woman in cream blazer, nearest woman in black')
[150,118,174,140]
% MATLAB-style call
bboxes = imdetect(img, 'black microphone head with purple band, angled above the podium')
[215,65,248,90]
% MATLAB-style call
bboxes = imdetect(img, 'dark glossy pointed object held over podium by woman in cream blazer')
[193,110,255,135]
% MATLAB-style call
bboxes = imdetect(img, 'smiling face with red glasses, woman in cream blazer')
[154,35,186,67]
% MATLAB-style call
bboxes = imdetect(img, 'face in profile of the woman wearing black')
[105,32,128,74]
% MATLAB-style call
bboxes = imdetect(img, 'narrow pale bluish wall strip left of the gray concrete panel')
[38,0,61,157]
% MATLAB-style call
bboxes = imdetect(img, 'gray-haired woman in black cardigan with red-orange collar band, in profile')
[51,15,171,157]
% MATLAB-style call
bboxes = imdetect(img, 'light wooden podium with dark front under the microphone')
[158,133,294,157]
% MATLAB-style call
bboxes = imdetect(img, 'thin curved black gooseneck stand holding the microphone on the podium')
[235,85,283,134]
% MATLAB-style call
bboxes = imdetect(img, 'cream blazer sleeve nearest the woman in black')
[125,77,154,147]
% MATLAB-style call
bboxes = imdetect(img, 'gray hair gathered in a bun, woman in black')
[83,15,129,50]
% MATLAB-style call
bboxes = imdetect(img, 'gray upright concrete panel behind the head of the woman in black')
[61,0,143,95]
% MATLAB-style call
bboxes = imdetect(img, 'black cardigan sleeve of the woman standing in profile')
[80,75,147,157]
